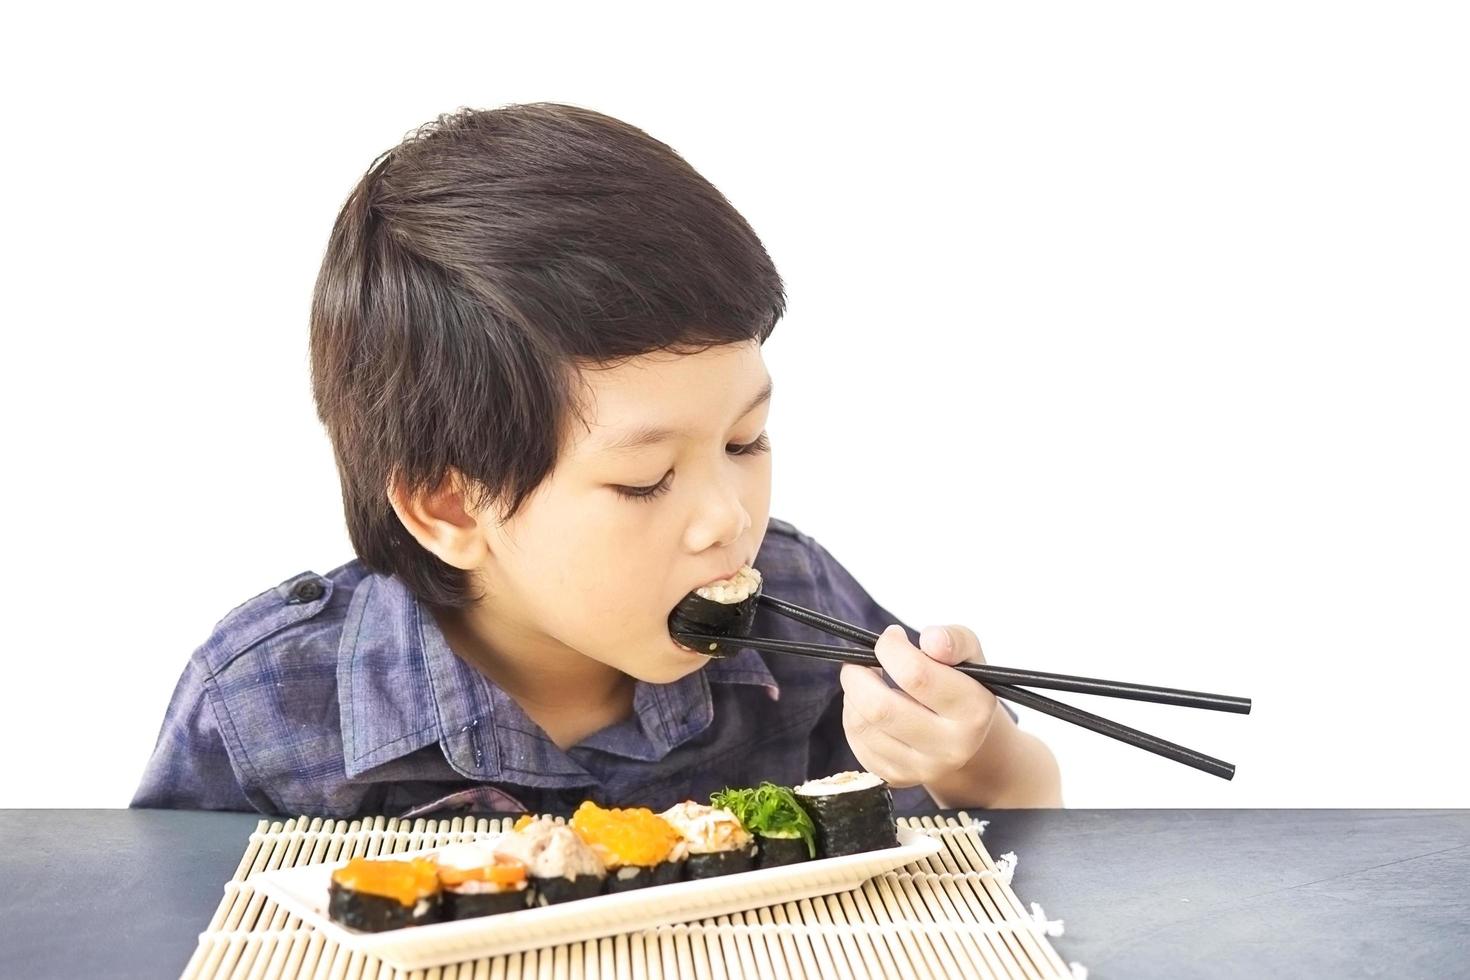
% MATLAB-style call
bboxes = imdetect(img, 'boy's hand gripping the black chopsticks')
[841,626,995,788]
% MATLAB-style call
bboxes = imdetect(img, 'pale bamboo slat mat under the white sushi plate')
[184,813,1086,980]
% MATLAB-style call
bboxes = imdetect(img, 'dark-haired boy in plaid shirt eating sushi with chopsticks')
[132,103,1060,817]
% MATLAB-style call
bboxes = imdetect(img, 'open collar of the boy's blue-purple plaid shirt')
[337,574,781,788]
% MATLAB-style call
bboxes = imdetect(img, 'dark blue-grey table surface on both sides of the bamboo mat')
[0,810,1470,980]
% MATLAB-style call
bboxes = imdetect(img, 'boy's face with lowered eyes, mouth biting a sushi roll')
[479,342,770,683]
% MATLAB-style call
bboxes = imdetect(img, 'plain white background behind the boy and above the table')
[0,3,1470,807]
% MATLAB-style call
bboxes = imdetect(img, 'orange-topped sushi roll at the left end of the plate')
[326,858,441,933]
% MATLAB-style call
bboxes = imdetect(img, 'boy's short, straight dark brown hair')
[312,103,785,607]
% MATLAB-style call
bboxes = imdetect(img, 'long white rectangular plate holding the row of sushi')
[248,827,944,970]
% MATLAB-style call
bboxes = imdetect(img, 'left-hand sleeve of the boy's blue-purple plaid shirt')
[129,658,259,813]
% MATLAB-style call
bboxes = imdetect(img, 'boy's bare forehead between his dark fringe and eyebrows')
[561,342,770,453]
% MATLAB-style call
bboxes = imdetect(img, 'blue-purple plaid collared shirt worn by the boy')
[132,519,933,817]
